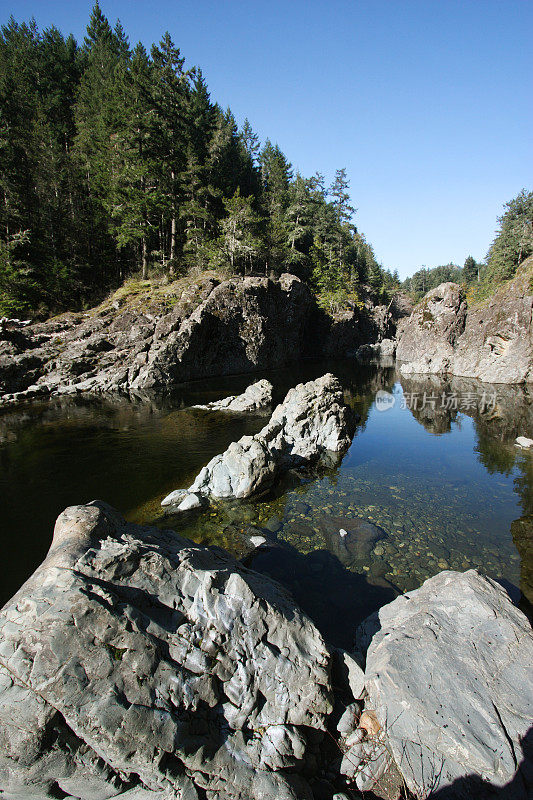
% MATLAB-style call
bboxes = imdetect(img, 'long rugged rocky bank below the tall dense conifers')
[0,274,395,402]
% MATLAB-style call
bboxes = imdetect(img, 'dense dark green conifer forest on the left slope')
[0,3,399,314]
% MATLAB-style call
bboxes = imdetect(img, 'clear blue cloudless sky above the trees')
[0,0,533,277]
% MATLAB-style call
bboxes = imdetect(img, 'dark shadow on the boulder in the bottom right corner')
[428,726,533,800]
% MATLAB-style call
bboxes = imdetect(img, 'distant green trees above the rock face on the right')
[402,189,533,300]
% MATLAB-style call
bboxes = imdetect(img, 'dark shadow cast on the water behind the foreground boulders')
[244,543,400,650]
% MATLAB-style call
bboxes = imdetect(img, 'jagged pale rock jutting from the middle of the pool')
[163,374,354,511]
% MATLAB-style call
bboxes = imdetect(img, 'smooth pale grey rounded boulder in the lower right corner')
[358,570,533,800]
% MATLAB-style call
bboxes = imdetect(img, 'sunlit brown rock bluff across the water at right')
[396,257,533,384]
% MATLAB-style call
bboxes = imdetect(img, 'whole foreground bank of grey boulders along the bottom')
[0,503,533,800]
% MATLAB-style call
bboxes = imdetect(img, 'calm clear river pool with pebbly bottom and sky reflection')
[0,361,533,643]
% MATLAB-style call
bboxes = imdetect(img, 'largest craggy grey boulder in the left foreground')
[0,503,331,800]
